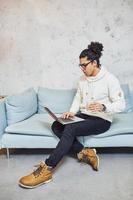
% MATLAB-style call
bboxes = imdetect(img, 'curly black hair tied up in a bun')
[79,42,103,67]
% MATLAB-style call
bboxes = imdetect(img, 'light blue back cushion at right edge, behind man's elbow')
[121,84,133,112]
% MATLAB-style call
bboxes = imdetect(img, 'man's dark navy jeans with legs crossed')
[45,113,111,168]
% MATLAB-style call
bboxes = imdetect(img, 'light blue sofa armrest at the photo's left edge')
[0,99,7,138]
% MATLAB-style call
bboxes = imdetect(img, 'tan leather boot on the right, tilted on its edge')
[77,147,99,171]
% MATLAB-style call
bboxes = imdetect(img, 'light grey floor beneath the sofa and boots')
[0,150,133,200]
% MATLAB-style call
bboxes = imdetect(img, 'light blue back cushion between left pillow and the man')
[38,87,76,113]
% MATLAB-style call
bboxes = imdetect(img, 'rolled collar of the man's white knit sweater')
[86,67,107,82]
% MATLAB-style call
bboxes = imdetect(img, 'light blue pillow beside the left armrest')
[6,88,37,125]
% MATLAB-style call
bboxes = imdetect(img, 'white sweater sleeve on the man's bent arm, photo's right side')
[105,76,125,113]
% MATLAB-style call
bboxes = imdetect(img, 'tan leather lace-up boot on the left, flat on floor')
[19,162,52,188]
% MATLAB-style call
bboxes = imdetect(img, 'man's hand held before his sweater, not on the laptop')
[86,102,104,112]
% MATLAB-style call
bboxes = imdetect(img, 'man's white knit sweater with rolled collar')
[70,67,125,122]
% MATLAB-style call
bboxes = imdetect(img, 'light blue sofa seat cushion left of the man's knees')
[5,114,58,137]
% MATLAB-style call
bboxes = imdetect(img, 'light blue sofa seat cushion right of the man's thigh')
[87,112,133,138]
